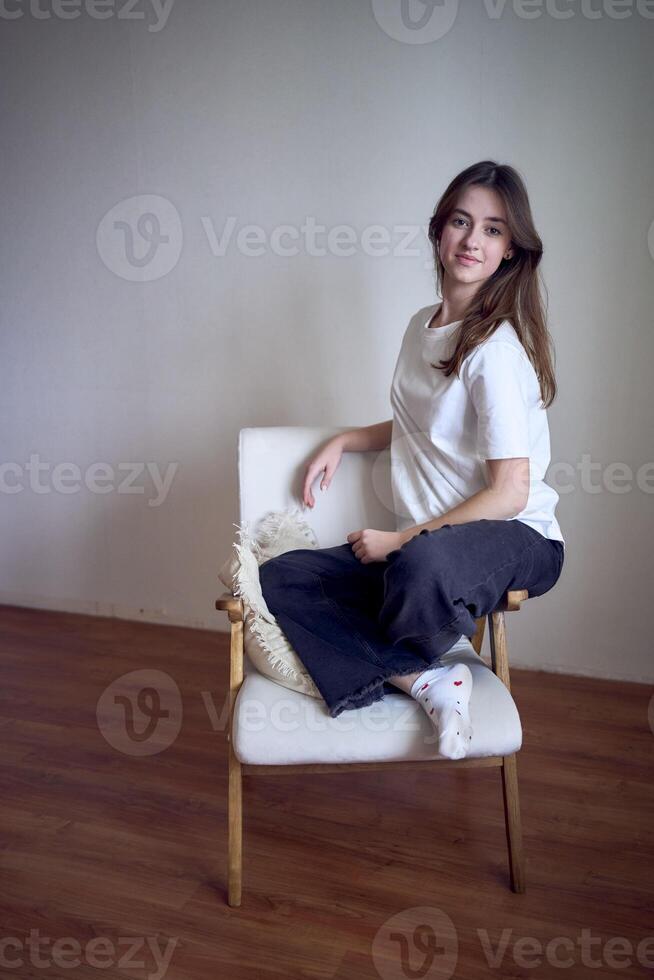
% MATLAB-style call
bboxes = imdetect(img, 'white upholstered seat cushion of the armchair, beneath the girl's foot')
[232,636,522,766]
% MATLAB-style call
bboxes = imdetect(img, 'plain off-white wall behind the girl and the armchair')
[0,0,654,681]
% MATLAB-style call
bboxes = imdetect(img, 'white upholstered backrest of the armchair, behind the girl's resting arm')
[238,426,396,548]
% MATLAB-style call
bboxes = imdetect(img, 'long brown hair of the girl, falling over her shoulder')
[429,160,556,408]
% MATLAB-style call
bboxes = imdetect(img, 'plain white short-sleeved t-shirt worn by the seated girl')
[390,303,565,546]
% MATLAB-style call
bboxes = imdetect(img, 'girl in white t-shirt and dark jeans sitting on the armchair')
[259,160,565,758]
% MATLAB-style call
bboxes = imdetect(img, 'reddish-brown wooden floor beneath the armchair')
[0,606,654,980]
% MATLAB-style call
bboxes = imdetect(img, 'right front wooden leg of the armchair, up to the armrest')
[488,611,526,893]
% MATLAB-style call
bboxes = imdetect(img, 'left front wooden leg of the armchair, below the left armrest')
[227,611,243,907]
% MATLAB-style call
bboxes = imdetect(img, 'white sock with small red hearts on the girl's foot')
[411,663,473,759]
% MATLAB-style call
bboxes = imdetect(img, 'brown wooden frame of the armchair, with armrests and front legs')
[216,589,529,907]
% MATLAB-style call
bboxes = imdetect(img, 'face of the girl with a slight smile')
[439,185,513,285]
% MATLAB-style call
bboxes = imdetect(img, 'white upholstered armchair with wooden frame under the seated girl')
[216,426,528,906]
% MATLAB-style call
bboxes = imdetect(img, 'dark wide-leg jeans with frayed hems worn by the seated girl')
[259,519,564,718]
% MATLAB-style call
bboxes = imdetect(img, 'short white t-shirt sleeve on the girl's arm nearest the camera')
[462,341,530,459]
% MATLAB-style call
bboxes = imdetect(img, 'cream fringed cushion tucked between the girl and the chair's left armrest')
[218,508,322,698]
